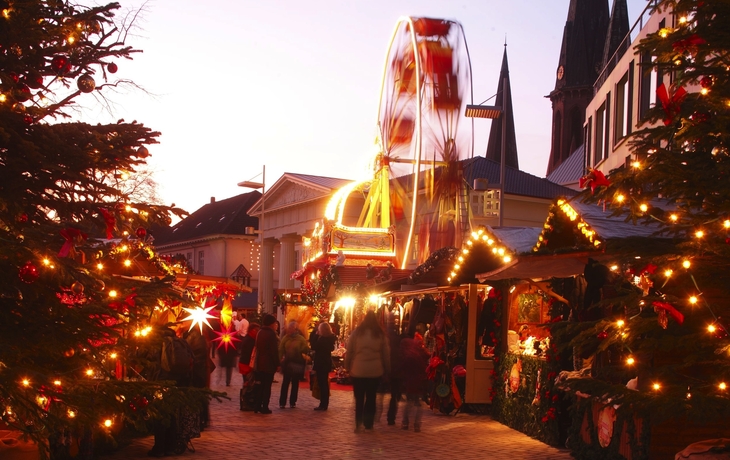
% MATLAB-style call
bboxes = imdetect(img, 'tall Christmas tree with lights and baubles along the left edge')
[0,0,208,456]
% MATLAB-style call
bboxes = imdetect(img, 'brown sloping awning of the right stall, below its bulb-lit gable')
[476,252,602,283]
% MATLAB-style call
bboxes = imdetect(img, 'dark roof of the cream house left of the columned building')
[154,191,261,247]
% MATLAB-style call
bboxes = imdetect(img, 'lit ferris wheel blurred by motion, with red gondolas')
[358,17,474,268]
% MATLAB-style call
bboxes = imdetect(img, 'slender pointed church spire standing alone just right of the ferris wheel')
[486,45,519,169]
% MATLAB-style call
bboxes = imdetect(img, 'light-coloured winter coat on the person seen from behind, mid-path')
[345,329,390,378]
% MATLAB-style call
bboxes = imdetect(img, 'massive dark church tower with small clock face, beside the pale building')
[547,0,608,174]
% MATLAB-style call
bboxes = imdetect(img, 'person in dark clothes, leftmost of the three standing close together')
[254,315,279,414]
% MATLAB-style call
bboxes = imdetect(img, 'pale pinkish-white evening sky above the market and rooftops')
[78,0,646,216]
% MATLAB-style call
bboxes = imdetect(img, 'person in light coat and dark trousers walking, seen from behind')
[345,311,390,433]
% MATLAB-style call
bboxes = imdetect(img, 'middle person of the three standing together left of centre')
[279,321,309,409]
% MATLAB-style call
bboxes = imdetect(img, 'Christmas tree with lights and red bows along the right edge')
[552,0,730,458]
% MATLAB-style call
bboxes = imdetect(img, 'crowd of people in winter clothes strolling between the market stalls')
[149,311,429,456]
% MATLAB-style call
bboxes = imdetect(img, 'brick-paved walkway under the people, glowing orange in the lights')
[104,369,572,460]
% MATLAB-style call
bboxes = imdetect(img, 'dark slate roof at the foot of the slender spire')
[464,157,578,199]
